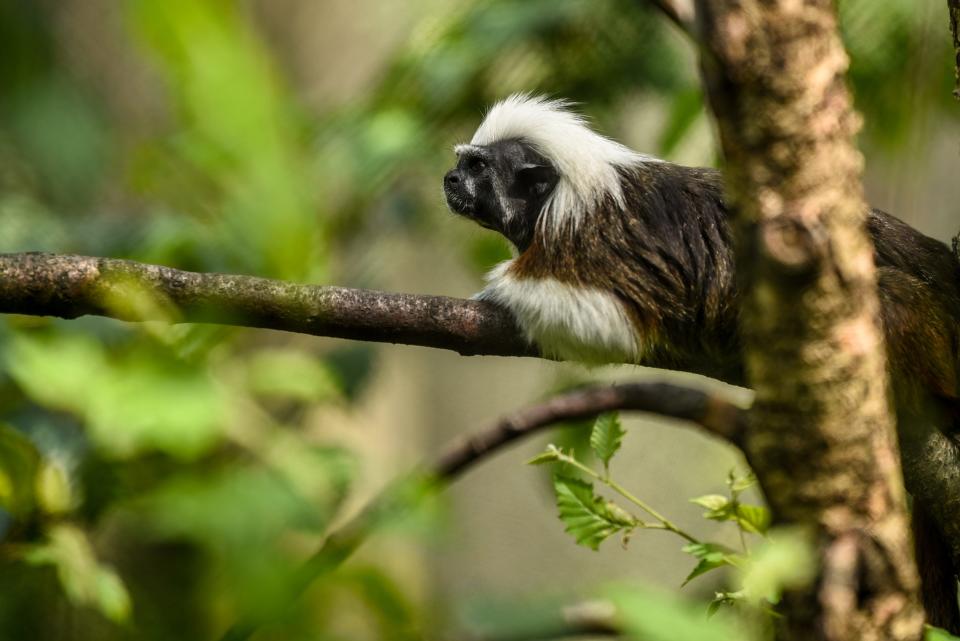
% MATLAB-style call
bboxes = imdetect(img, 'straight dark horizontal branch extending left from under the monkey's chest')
[0,253,537,356]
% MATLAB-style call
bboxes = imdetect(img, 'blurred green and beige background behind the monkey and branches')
[0,0,960,641]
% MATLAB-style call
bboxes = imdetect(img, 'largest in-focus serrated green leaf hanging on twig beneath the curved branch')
[553,474,636,550]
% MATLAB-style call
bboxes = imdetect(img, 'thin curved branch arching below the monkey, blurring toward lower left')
[221,383,748,641]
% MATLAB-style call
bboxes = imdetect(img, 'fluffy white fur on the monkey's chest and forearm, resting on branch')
[474,260,646,364]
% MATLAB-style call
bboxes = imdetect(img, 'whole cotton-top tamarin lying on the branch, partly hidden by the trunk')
[444,95,960,632]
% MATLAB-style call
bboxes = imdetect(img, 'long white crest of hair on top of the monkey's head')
[470,94,657,234]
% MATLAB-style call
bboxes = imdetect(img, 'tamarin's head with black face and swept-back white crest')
[443,94,650,252]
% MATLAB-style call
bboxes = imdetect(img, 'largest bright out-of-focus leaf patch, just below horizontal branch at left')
[6,333,229,459]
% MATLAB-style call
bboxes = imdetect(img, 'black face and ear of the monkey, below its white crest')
[443,140,560,251]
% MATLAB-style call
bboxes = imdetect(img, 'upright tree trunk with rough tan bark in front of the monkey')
[697,0,923,641]
